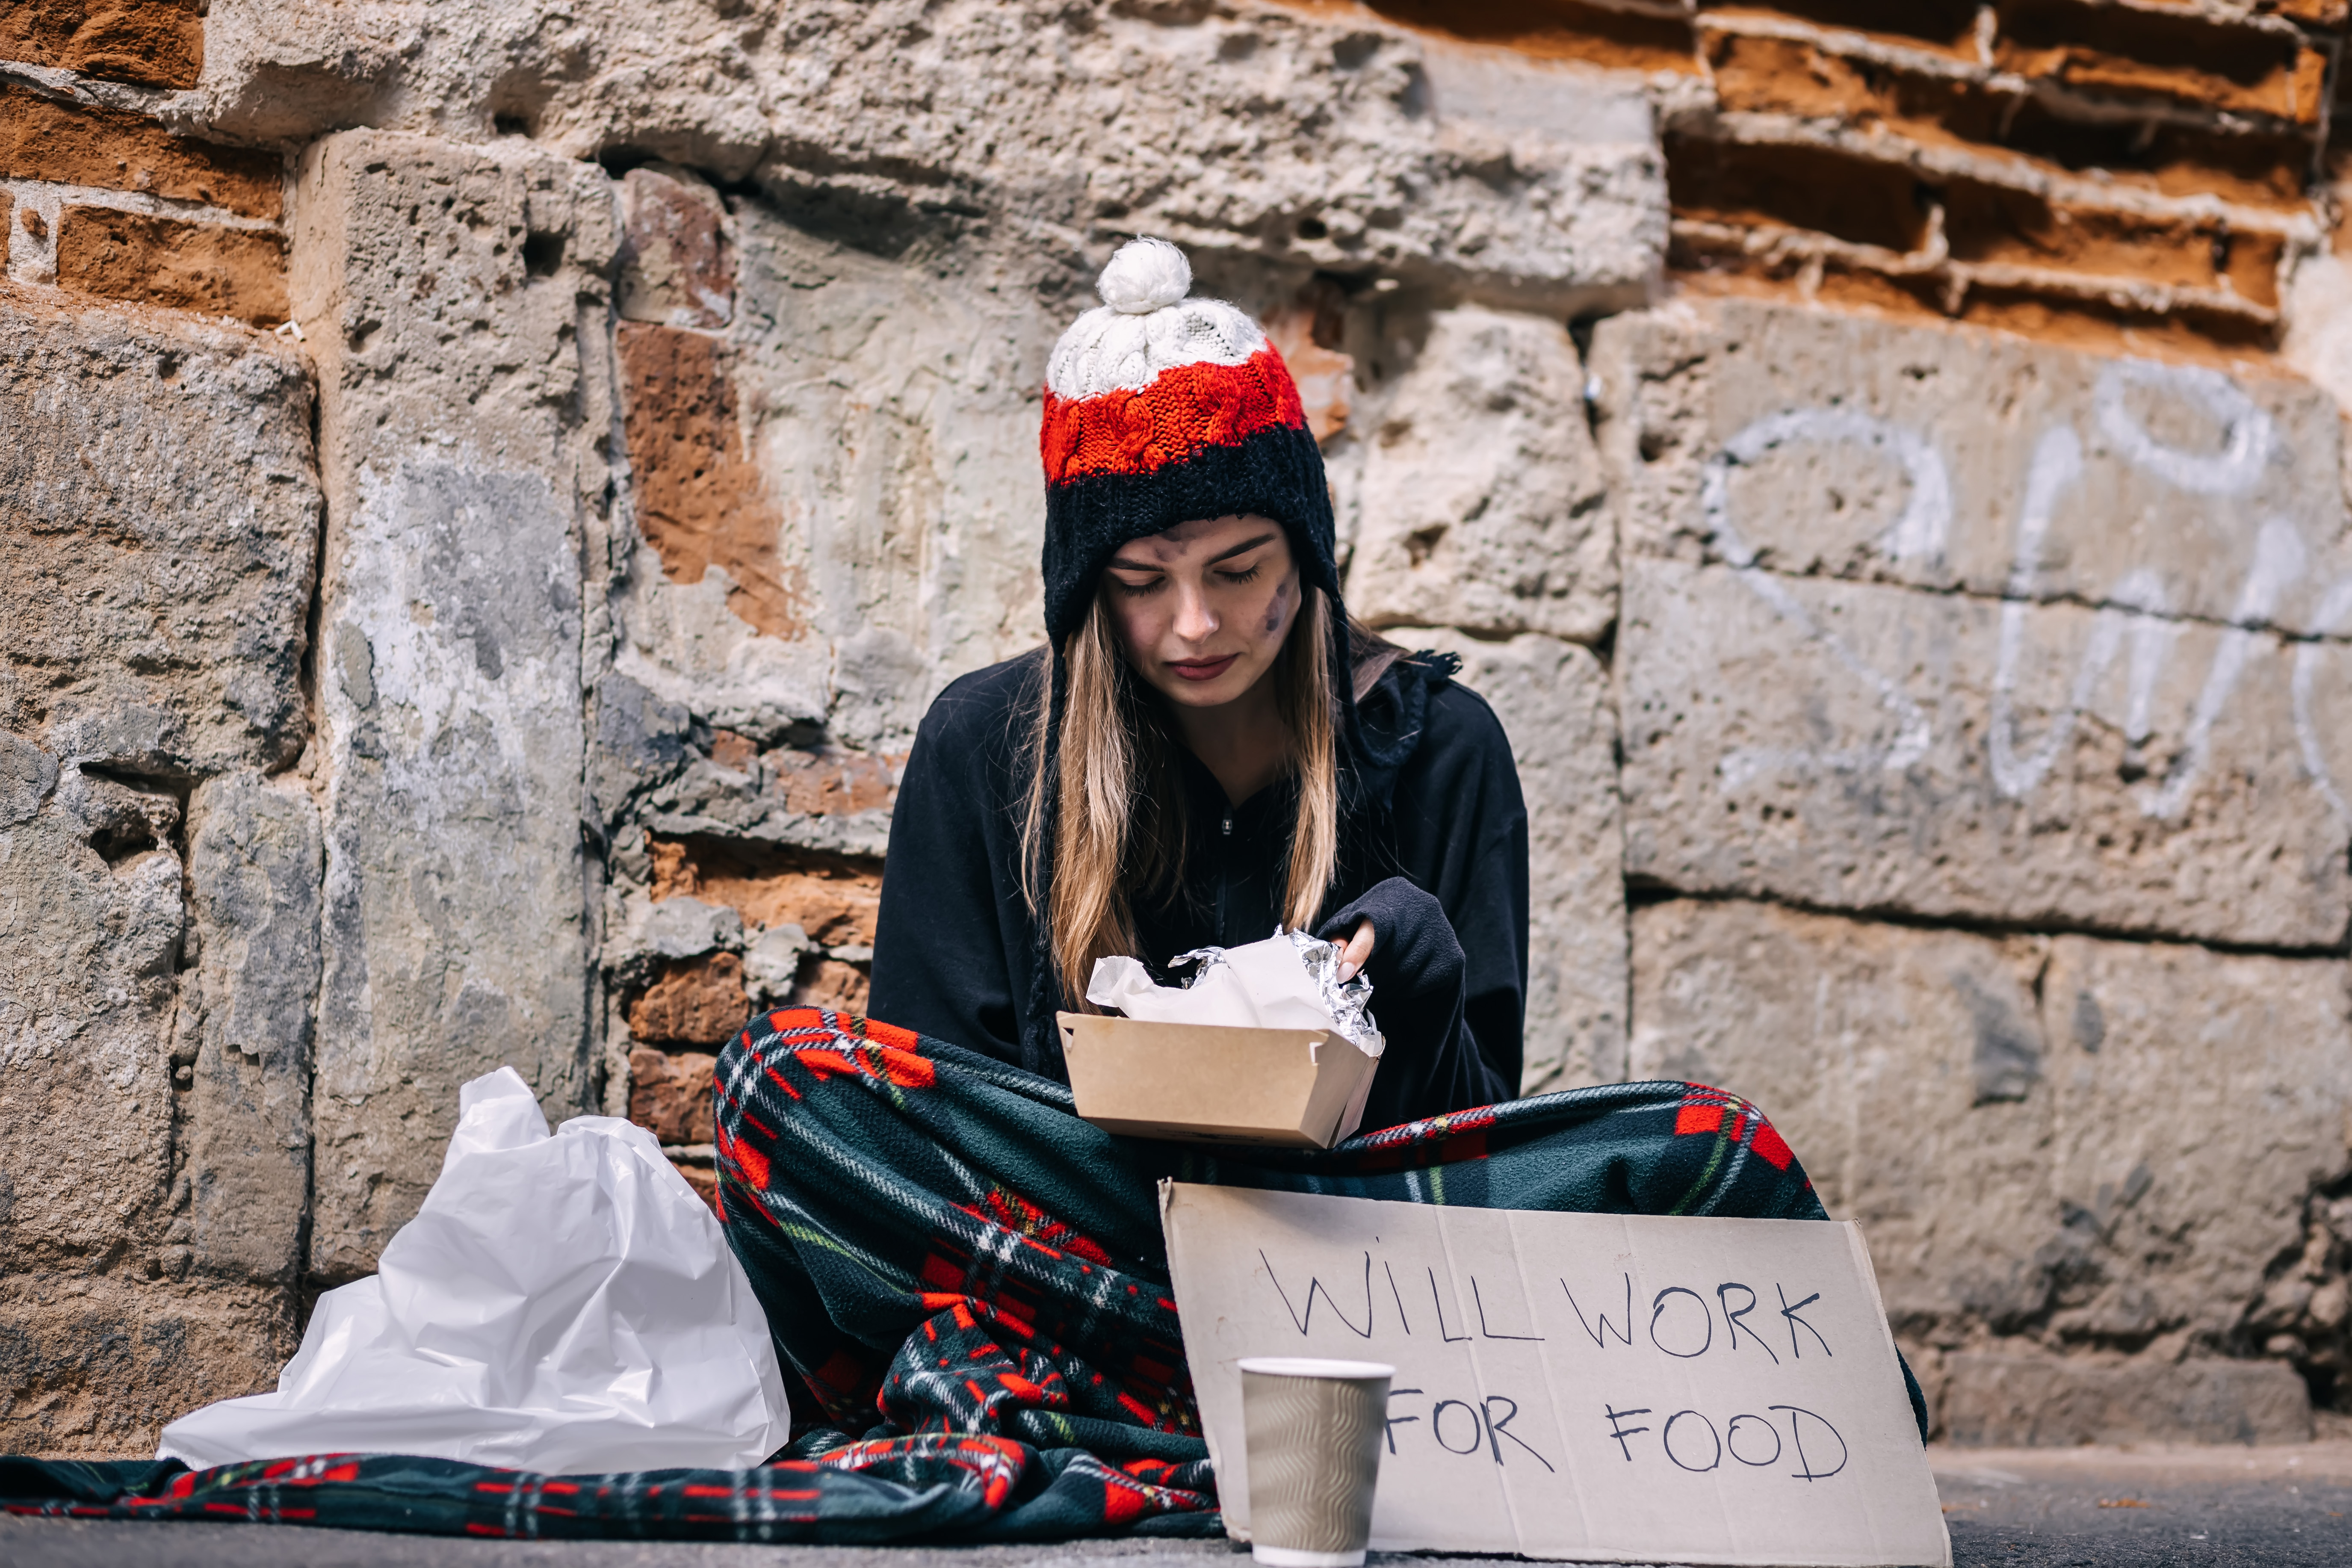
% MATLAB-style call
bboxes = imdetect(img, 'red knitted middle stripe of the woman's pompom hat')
[1037,343,1308,484]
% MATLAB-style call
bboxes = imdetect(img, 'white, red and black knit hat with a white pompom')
[1037,240,1345,644]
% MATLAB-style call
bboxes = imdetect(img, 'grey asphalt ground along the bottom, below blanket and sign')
[0,1441,2352,1568]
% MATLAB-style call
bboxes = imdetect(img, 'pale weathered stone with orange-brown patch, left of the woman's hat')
[619,215,1063,752]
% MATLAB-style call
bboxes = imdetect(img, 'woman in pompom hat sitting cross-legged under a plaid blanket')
[715,240,1924,1504]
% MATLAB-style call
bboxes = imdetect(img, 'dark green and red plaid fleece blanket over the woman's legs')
[0,1009,1927,1544]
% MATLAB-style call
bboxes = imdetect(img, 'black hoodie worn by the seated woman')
[868,653,1527,1131]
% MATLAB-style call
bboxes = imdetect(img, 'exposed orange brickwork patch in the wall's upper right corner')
[1317,0,2345,353]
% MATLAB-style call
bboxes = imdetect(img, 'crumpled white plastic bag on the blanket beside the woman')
[158,1067,790,1474]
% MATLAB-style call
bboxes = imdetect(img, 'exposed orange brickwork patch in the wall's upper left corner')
[0,0,287,327]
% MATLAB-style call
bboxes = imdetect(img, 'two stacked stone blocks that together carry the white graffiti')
[1595,301,2352,948]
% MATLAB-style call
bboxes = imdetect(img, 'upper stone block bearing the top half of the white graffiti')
[1593,301,2352,632]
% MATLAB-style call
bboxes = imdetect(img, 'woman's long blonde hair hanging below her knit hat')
[1021,588,1395,1011]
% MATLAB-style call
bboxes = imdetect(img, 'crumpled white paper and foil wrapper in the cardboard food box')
[1087,931,1388,1055]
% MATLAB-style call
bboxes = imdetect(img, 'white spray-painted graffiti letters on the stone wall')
[1701,360,2352,821]
